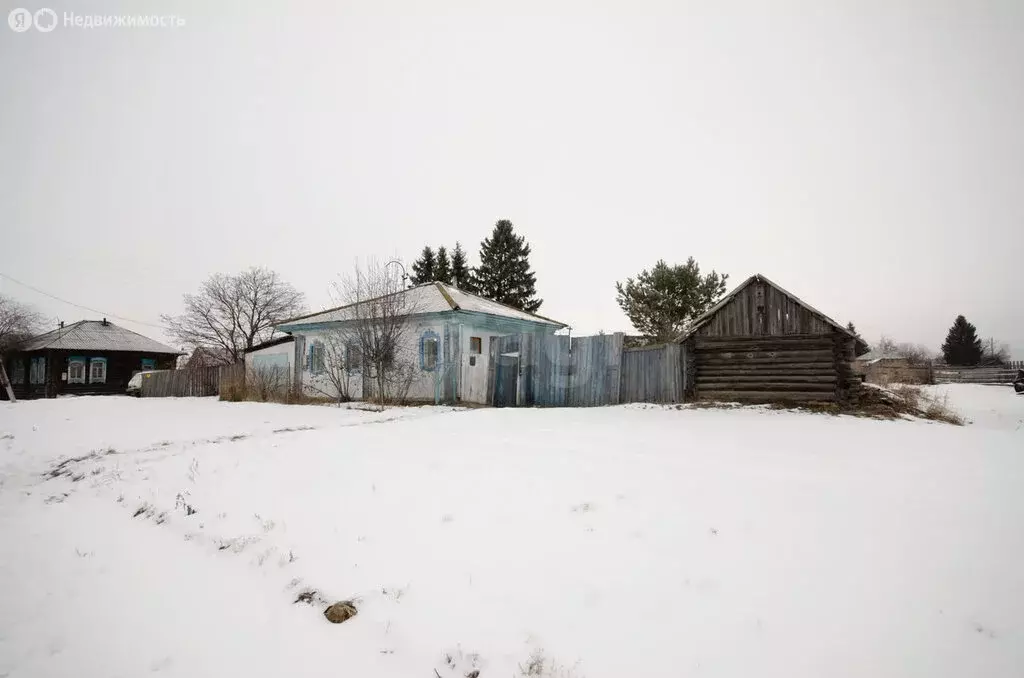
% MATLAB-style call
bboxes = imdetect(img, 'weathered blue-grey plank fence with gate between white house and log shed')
[487,334,685,408]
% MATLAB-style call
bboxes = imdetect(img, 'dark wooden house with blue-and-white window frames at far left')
[0,317,179,399]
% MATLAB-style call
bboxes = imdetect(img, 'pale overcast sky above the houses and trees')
[0,0,1024,358]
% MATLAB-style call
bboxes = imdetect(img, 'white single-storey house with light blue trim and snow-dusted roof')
[268,283,566,405]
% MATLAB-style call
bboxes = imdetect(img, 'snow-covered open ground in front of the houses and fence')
[0,386,1024,678]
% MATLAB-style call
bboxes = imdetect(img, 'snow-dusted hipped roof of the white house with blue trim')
[278,282,566,332]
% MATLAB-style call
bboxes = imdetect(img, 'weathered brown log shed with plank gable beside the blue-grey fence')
[682,273,868,402]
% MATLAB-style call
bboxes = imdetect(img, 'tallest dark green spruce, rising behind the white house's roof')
[473,219,544,313]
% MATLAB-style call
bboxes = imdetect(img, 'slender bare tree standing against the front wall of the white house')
[325,262,417,409]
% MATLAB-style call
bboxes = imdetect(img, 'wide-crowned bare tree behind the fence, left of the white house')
[161,267,304,365]
